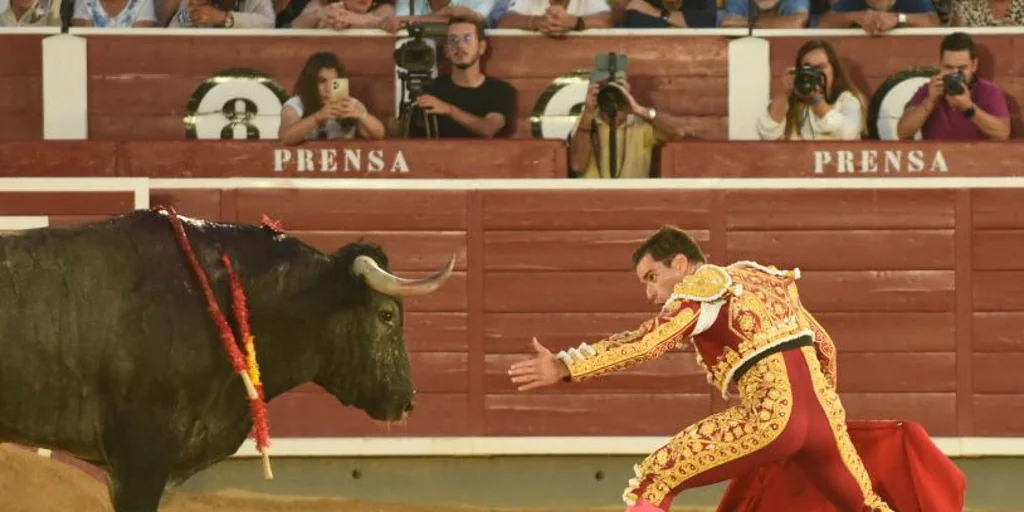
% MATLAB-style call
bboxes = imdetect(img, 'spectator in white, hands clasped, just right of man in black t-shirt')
[498,0,613,37]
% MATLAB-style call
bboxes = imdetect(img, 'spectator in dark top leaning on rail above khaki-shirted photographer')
[617,0,718,29]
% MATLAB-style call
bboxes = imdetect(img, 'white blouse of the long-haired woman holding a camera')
[757,91,864,140]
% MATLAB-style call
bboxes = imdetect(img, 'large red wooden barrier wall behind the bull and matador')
[2,188,1024,437]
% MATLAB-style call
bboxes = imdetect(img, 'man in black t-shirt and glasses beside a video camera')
[409,17,516,138]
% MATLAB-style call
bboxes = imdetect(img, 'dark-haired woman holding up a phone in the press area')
[278,52,384,145]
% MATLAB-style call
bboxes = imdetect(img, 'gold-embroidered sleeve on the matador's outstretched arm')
[559,307,697,381]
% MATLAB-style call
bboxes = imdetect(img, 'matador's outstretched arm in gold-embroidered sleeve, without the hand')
[556,300,700,382]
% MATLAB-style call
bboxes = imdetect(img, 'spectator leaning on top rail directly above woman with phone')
[292,0,398,29]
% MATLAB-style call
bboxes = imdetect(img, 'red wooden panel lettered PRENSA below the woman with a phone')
[0,139,567,179]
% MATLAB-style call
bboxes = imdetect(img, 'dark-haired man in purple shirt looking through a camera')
[896,32,1010,140]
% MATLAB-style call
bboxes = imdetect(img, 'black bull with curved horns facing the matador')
[0,211,455,512]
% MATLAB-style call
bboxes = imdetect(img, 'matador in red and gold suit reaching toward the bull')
[509,226,892,512]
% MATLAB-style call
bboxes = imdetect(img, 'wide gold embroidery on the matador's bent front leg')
[623,353,793,505]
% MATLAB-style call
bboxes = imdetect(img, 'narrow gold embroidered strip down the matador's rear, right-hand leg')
[801,347,893,512]
